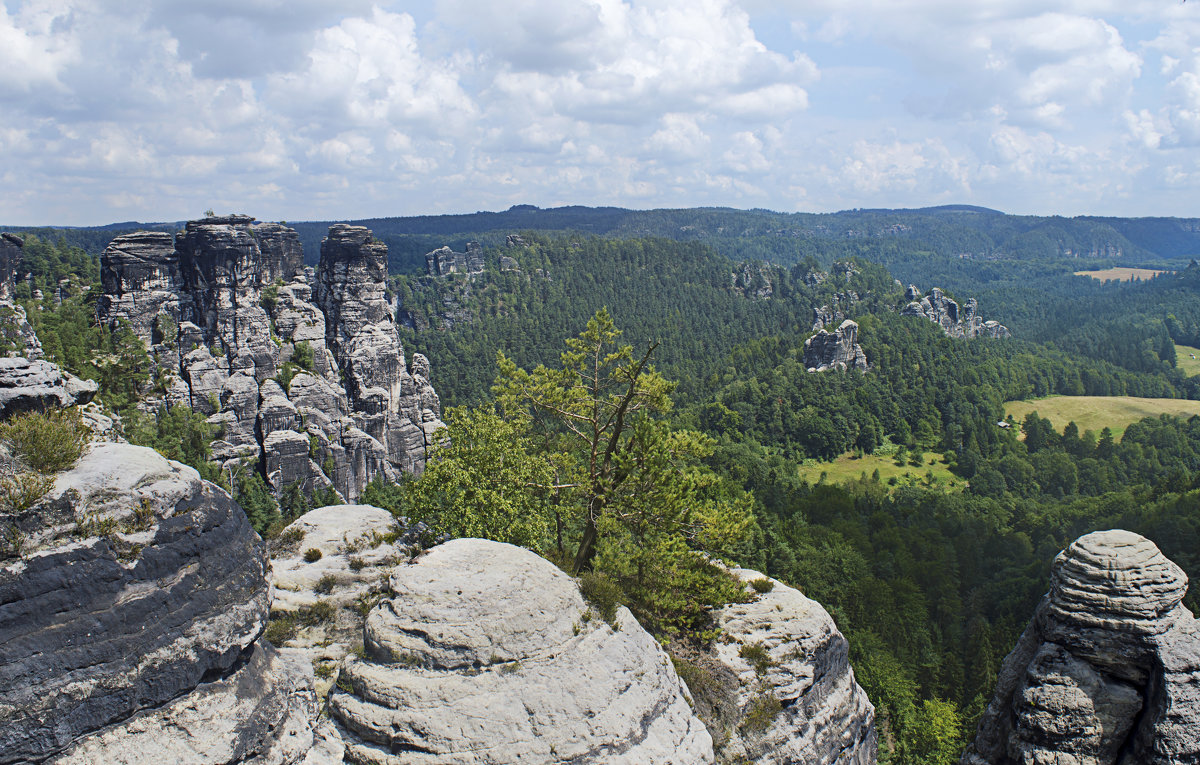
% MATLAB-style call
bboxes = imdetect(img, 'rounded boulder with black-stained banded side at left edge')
[0,444,269,763]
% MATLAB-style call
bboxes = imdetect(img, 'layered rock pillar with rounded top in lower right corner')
[962,530,1200,765]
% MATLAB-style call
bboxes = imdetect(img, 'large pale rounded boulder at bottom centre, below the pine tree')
[330,540,713,765]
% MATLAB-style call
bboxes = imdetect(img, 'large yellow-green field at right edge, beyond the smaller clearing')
[1004,395,1200,438]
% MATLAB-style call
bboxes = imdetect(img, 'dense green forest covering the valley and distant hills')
[7,207,1200,764]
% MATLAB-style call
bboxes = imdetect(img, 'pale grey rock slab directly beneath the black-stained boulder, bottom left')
[48,640,321,765]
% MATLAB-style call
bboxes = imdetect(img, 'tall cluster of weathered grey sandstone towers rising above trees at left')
[96,216,442,500]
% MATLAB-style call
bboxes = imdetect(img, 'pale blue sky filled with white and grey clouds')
[0,0,1200,225]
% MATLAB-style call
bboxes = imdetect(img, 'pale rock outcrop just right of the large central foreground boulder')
[715,568,877,765]
